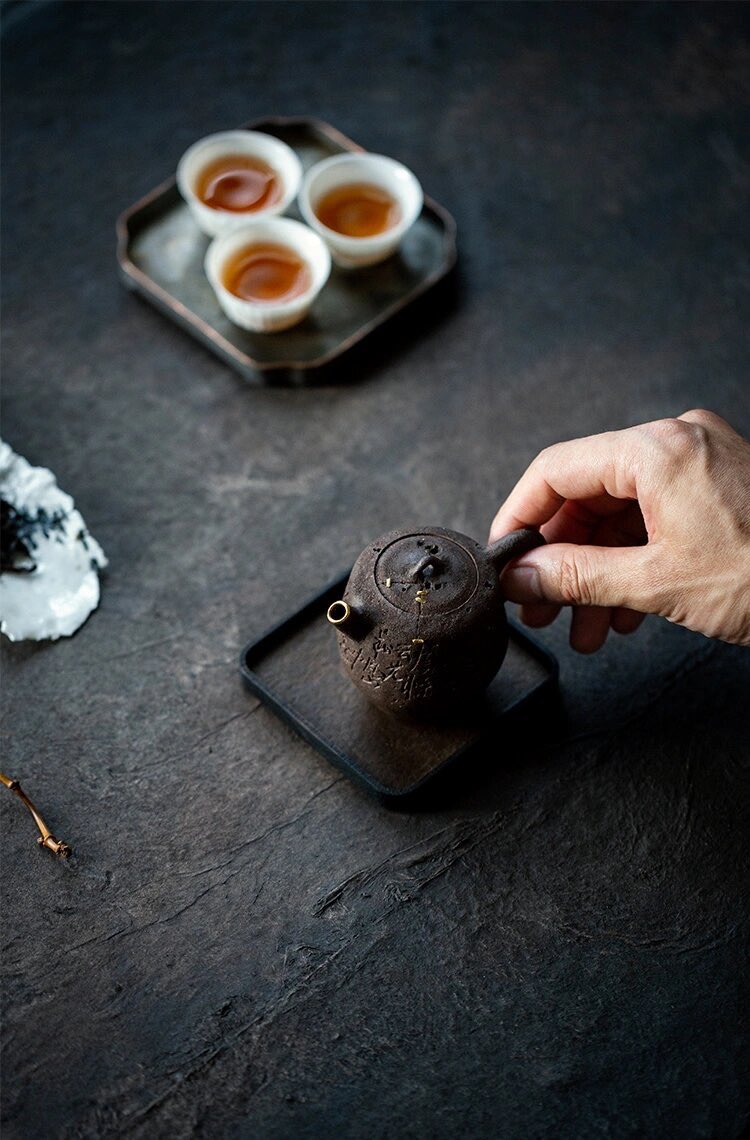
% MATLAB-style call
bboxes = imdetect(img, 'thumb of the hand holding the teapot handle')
[503,543,652,613]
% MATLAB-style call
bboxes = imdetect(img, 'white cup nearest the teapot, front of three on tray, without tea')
[204,218,331,333]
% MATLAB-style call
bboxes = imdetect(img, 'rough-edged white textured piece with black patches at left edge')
[0,440,107,641]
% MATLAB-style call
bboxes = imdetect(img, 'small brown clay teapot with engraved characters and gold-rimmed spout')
[327,527,544,717]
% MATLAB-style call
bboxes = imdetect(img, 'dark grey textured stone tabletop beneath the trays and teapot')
[0,2,750,1140]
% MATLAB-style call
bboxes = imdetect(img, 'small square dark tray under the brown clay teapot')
[239,573,557,800]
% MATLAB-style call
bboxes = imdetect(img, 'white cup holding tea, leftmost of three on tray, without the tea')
[177,131,302,237]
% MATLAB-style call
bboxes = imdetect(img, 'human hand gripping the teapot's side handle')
[490,410,750,653]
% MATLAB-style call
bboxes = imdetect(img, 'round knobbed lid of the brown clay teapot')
[374,531,479,613]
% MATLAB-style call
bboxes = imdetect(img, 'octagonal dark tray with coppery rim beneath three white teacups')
[117,117,456,382]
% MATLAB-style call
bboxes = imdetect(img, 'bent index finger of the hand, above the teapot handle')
[489,429,637,543]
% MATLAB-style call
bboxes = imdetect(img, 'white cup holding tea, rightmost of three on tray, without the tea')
[299,154,424,268]
